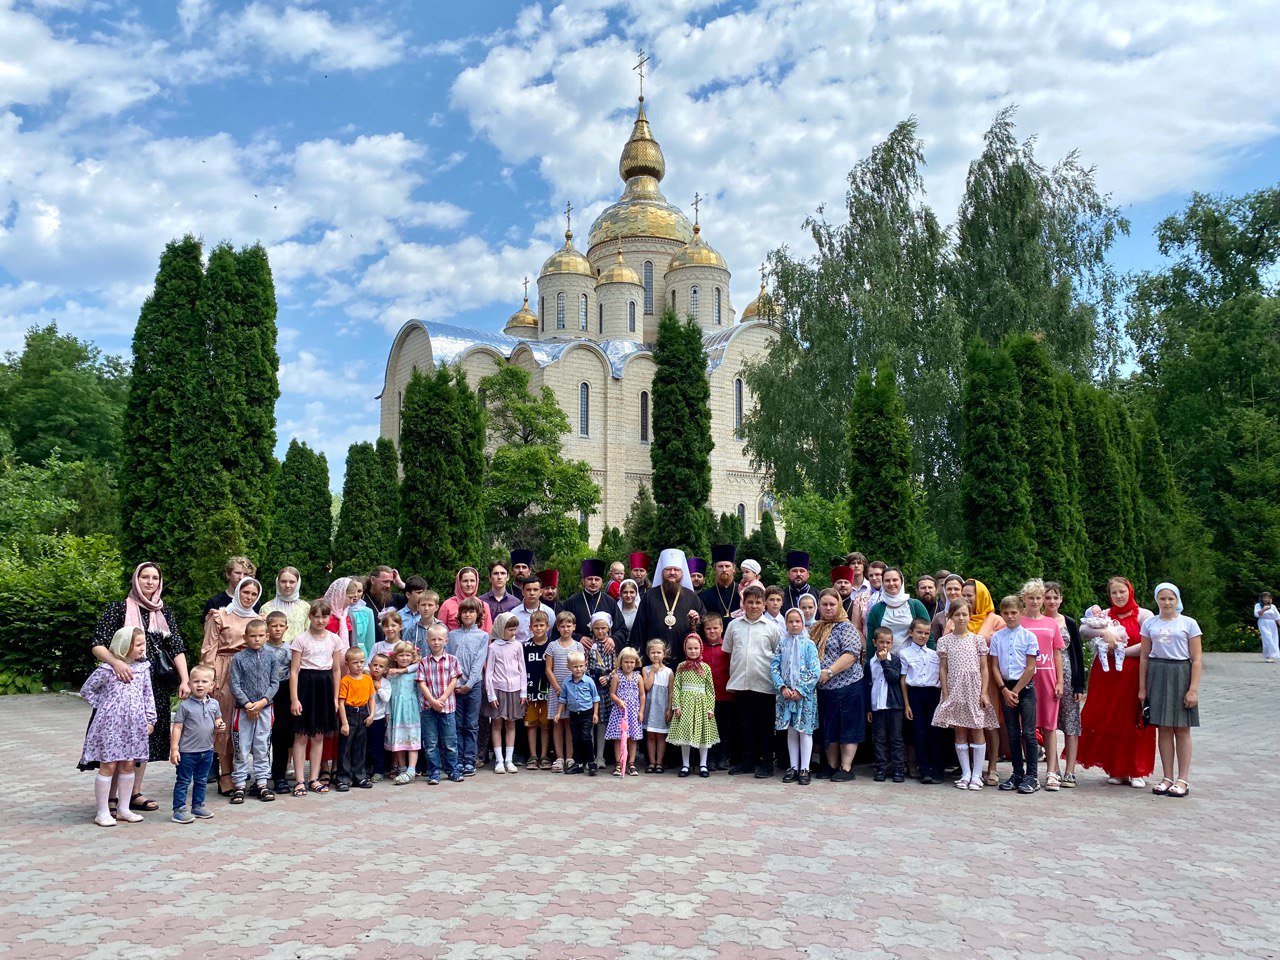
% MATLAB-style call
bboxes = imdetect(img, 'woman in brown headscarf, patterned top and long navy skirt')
[809,588,867,783]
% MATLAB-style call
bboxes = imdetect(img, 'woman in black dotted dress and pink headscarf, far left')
[84,563,189,810]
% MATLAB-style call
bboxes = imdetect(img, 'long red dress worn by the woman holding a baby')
[1075,616,1156,780]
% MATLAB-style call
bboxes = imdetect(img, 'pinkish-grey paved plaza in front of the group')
[0,654,1280,960]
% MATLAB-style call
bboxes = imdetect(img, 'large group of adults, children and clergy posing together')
[81,545,1201,827]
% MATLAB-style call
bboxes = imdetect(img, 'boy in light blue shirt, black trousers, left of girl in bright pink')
[987,596,1039,794]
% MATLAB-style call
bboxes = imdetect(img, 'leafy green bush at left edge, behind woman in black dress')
[0,535,124,692]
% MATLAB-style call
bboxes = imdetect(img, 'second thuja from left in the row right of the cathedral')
[960,340,1039,594]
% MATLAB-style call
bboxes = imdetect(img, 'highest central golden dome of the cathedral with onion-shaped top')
[586,101,694,250]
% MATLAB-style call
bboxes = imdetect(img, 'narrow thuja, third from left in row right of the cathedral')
[1009,334,1088,599]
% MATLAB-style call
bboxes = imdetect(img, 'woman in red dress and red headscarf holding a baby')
[1078,577,1156,787]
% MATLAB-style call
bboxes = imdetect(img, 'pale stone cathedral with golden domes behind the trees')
[380,95,777,552]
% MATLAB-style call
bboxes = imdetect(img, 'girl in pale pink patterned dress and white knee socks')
[933,600,998,790]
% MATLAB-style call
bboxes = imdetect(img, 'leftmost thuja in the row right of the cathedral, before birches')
[847,362,920,570]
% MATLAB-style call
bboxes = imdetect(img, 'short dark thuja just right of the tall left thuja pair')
[265,440,333,596]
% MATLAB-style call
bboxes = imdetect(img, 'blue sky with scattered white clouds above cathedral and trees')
[0,0,1280,489]
